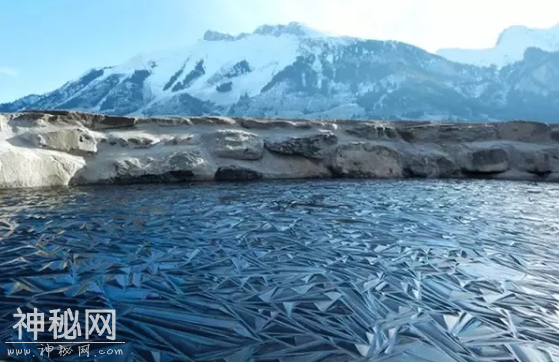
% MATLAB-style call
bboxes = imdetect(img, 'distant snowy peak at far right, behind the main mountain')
[437,24,559,68]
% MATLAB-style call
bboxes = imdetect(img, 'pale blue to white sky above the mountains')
[0,0,559,102]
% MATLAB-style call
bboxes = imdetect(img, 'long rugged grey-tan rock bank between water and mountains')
[0,111,559,188]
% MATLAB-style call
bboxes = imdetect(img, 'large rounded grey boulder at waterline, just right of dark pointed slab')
[332,142,404,178]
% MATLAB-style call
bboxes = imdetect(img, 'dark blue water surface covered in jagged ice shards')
[0,181,559,362]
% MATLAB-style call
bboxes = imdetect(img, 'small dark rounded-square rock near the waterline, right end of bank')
[462,148,509,174]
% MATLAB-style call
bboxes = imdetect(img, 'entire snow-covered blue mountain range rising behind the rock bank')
[0,23,559,122]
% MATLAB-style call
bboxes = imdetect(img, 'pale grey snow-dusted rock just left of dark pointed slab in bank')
[202,130,264,160]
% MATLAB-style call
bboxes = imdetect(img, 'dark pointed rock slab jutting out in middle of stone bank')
[264,132,338,159]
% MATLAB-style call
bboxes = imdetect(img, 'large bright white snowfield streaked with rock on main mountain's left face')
[82,29,310,110]
